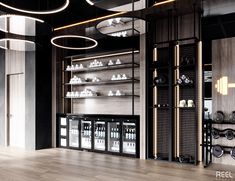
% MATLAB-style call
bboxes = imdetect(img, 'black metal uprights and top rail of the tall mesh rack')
[146,33,199,165]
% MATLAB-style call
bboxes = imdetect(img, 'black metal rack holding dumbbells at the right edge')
[202,119,235,167]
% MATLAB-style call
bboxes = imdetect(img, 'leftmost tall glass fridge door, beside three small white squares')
[68,118,80,149]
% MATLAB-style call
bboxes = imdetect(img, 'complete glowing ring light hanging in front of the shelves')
[51,35,98,50]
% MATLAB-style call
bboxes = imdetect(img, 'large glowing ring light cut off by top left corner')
[0,0,70,15]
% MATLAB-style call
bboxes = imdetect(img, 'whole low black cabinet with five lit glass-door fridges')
[57,114,139,157]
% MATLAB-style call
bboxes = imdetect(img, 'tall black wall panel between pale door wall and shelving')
[36,38,52,149]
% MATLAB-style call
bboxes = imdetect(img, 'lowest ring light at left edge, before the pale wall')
[0,38,35,51]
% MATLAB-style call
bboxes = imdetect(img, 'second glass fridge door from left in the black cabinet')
[81,119,92,149]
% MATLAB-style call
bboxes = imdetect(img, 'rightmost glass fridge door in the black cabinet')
[122,120,137,155]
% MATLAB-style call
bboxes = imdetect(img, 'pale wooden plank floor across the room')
[0,148,235,181]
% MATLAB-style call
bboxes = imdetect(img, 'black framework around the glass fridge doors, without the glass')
[57,114,140,158]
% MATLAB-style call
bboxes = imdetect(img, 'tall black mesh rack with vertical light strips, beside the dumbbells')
[148,38,198,164]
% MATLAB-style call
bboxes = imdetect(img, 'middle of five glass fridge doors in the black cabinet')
[94,121,106,151]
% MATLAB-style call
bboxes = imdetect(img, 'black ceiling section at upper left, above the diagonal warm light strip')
[0,0,109,28]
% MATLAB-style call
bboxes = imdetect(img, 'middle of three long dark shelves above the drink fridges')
[65,79,140,86]
